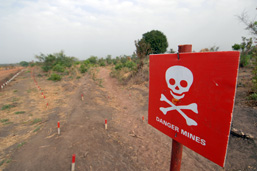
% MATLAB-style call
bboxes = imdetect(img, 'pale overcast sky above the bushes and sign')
[0,0,257,64]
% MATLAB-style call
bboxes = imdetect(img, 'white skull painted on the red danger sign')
[165,65,193,99]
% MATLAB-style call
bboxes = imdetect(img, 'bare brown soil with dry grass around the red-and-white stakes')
[0,67,257,171]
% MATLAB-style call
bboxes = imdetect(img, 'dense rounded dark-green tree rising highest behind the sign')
[141,30,168,55]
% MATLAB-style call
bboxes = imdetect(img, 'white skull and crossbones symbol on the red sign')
[160,65,198,126]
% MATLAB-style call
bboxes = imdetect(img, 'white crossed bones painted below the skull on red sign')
[160,94,198,126]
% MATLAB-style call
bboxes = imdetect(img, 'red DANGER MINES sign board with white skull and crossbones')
[148,46,239,166]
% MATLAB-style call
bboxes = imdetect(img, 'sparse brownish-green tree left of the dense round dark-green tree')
[135,38,152,70]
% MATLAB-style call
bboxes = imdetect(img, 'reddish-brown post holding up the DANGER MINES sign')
[170,45,192,171]
